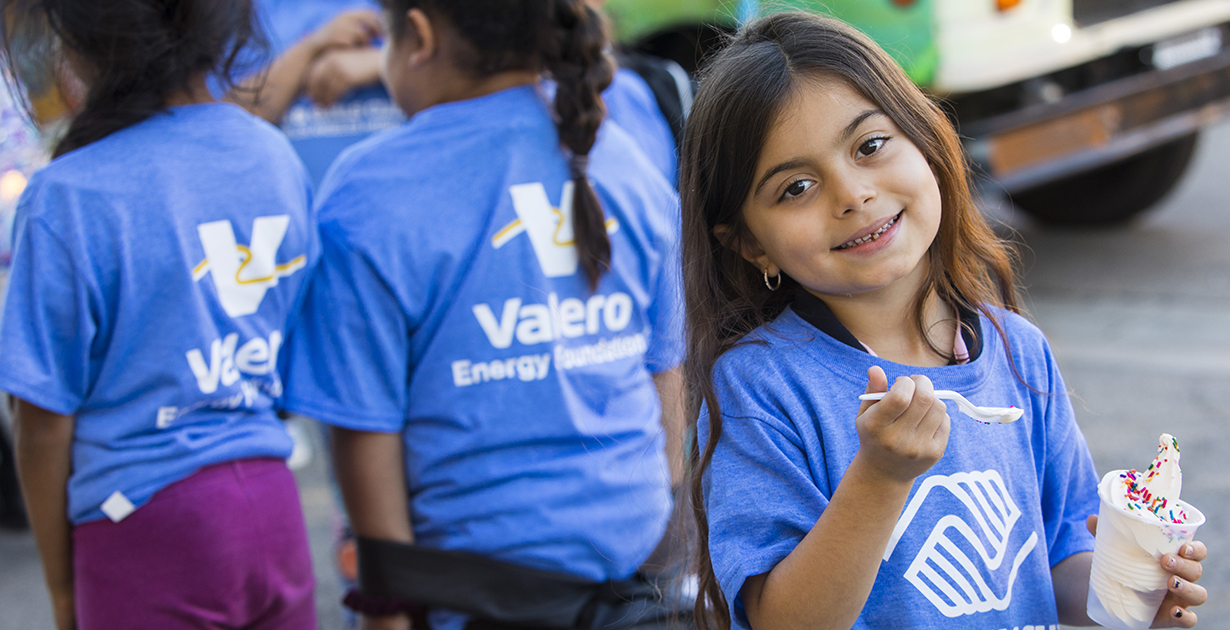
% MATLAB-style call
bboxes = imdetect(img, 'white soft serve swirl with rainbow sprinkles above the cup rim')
[1111,433,1187,523]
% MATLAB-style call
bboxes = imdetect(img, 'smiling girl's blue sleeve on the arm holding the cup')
[1042,346,1098,566]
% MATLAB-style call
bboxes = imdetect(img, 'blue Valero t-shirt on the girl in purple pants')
[0,103,319,524]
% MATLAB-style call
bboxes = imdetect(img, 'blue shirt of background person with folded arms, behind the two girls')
[257,0,406,185]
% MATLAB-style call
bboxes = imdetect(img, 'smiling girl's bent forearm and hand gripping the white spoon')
[740,368,948,630]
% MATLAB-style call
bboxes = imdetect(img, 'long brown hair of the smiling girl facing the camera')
[680,12,1018,630]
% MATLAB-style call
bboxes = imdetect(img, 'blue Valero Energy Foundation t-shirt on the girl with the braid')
[287,86,681,581]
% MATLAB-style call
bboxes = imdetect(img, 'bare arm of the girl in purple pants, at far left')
[14,399,76,630]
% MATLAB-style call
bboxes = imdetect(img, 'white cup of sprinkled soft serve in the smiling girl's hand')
[1086,434,1204,630]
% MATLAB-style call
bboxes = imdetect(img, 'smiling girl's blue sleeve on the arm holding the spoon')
[701,401,829,628]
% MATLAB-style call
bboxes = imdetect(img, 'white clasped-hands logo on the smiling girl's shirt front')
[884,470,1038,618]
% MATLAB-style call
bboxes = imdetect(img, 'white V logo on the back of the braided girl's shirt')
[491,181,619,278]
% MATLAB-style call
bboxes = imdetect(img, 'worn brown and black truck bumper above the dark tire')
[961,41,1230,192]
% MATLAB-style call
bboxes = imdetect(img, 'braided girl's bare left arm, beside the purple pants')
[332,427,415,630]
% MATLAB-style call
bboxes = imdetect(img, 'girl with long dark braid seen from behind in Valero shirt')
[287,0,686,629]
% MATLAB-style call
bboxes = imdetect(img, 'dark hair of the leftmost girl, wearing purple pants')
[0,0,266,156]
